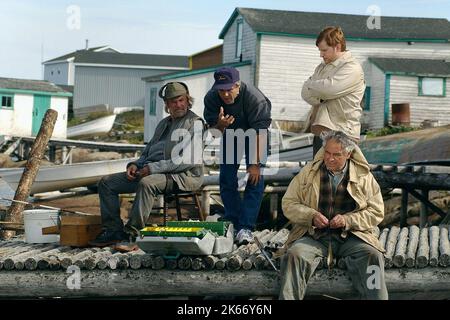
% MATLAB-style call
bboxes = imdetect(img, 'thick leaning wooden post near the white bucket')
[2,109,58,239]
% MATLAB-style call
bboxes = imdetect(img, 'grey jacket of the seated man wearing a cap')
[127,110,203,191]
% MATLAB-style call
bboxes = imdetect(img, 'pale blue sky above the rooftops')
[0,0,450,79]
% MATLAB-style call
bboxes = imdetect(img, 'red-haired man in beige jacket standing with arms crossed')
[302,27,366,156]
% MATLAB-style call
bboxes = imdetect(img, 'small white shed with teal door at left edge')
[0,78,72,138]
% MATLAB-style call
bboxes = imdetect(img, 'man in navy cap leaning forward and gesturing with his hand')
[203,67,272,244]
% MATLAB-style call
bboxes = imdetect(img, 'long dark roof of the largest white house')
[219,8,450,42]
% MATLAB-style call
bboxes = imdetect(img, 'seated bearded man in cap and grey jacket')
[90,82,203,247]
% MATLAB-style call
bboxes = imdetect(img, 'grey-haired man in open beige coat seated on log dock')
[280,131,388,299]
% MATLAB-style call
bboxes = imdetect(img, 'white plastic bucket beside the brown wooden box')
[23,209,59,243]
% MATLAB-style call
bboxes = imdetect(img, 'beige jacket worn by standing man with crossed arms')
[302,51,366,140]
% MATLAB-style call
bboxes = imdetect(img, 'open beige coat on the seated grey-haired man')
[279,147,384,254]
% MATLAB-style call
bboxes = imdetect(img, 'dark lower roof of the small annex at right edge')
[369,58,450,76]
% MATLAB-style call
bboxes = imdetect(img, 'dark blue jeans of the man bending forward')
[219,131,264,231]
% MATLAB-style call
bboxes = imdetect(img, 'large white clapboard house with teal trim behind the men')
[142,8,450,138]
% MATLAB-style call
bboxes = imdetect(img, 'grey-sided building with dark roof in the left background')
[43,46,189,116]
